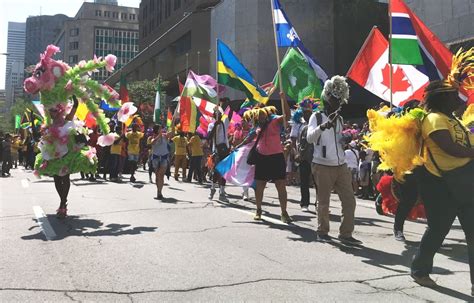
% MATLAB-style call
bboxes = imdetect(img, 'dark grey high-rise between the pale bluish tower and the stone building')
[25,14,71,67]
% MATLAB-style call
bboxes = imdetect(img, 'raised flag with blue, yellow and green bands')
[217,39,268,103]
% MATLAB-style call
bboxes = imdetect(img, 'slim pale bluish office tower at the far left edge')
[5,22,26,108]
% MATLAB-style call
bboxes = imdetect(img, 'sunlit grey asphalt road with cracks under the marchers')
[0,169,474,302]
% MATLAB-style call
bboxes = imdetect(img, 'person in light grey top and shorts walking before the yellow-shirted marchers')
[148,124,173,200]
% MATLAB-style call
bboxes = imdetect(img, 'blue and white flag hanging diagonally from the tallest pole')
[273,0,328,84]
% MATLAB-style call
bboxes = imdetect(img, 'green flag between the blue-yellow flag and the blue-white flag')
[273,48,322,102]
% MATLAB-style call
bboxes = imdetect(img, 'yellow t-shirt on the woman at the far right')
[421,113,471,177]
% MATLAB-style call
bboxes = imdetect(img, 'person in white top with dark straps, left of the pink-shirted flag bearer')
[207,106,230,202]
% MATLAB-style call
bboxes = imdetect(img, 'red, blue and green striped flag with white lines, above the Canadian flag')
[389,0,423,65]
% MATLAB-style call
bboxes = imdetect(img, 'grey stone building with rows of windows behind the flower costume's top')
[55,1,138,80]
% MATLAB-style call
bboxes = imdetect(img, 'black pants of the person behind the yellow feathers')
[392,174,418,231]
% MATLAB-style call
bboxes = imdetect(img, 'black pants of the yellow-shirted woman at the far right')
[411,168,474,284]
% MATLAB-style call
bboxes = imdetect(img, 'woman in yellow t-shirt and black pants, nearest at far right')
[411,81,474,291]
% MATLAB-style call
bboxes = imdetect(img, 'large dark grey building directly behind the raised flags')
[107,0,388,103]
